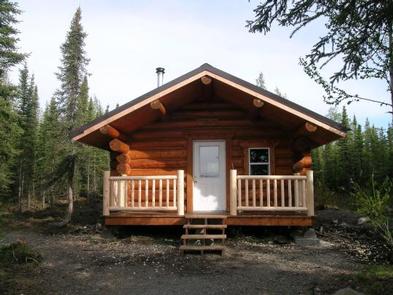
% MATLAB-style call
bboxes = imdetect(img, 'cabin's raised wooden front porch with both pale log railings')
[103,169,314,226]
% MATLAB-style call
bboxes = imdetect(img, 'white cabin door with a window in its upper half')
[193,141,226,212]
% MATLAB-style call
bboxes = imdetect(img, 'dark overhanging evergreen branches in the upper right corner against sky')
[247,0,393,122]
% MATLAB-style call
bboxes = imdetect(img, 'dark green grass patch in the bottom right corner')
[355,265,393,295]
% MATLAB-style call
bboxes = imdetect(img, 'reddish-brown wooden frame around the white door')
[186,136,232,213]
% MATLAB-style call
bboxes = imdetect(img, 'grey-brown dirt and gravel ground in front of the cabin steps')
[2,230,362,295]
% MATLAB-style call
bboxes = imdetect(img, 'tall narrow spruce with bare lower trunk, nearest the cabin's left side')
[56,8,89,223]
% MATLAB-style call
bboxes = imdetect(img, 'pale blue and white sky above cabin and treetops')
[11,0,391,127]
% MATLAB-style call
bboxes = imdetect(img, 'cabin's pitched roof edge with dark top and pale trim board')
[71,63,346,146]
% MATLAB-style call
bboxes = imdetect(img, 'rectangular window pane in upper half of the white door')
[199,146,220,177]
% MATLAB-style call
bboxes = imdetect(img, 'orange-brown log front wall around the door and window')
[111,99,294,209]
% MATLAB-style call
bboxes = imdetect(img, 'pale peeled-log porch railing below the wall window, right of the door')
[230,170,314,216]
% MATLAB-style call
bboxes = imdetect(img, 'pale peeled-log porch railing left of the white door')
[103,170,184,216]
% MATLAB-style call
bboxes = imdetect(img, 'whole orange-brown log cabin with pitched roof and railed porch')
[72,64,346,251]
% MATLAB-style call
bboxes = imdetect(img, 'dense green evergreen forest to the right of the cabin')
[312,107,393,197]
